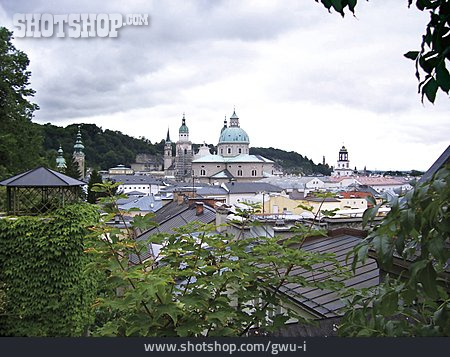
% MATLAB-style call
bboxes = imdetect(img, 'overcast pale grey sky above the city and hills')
[0,0,450,170]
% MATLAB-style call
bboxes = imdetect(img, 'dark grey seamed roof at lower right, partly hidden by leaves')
[280,234,380,318]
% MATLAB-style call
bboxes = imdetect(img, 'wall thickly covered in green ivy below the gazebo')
[0,204,98,336]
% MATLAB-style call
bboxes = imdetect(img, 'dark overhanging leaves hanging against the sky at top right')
[316,0,450,103]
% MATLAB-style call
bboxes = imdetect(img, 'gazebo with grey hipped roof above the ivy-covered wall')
[0,166,86,215]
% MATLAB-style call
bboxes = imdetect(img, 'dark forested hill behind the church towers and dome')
[36,124,331,175]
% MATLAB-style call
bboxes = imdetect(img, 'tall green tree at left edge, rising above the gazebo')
[0,27,44,179]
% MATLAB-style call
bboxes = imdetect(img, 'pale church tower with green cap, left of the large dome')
[175,113,193,181]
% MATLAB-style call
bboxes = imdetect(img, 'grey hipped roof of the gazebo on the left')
[0,166,86,187]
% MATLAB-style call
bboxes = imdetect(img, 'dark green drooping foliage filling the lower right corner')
[339,167,450,336]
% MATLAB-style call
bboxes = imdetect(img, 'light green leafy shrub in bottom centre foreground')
[89,183,342,336]
